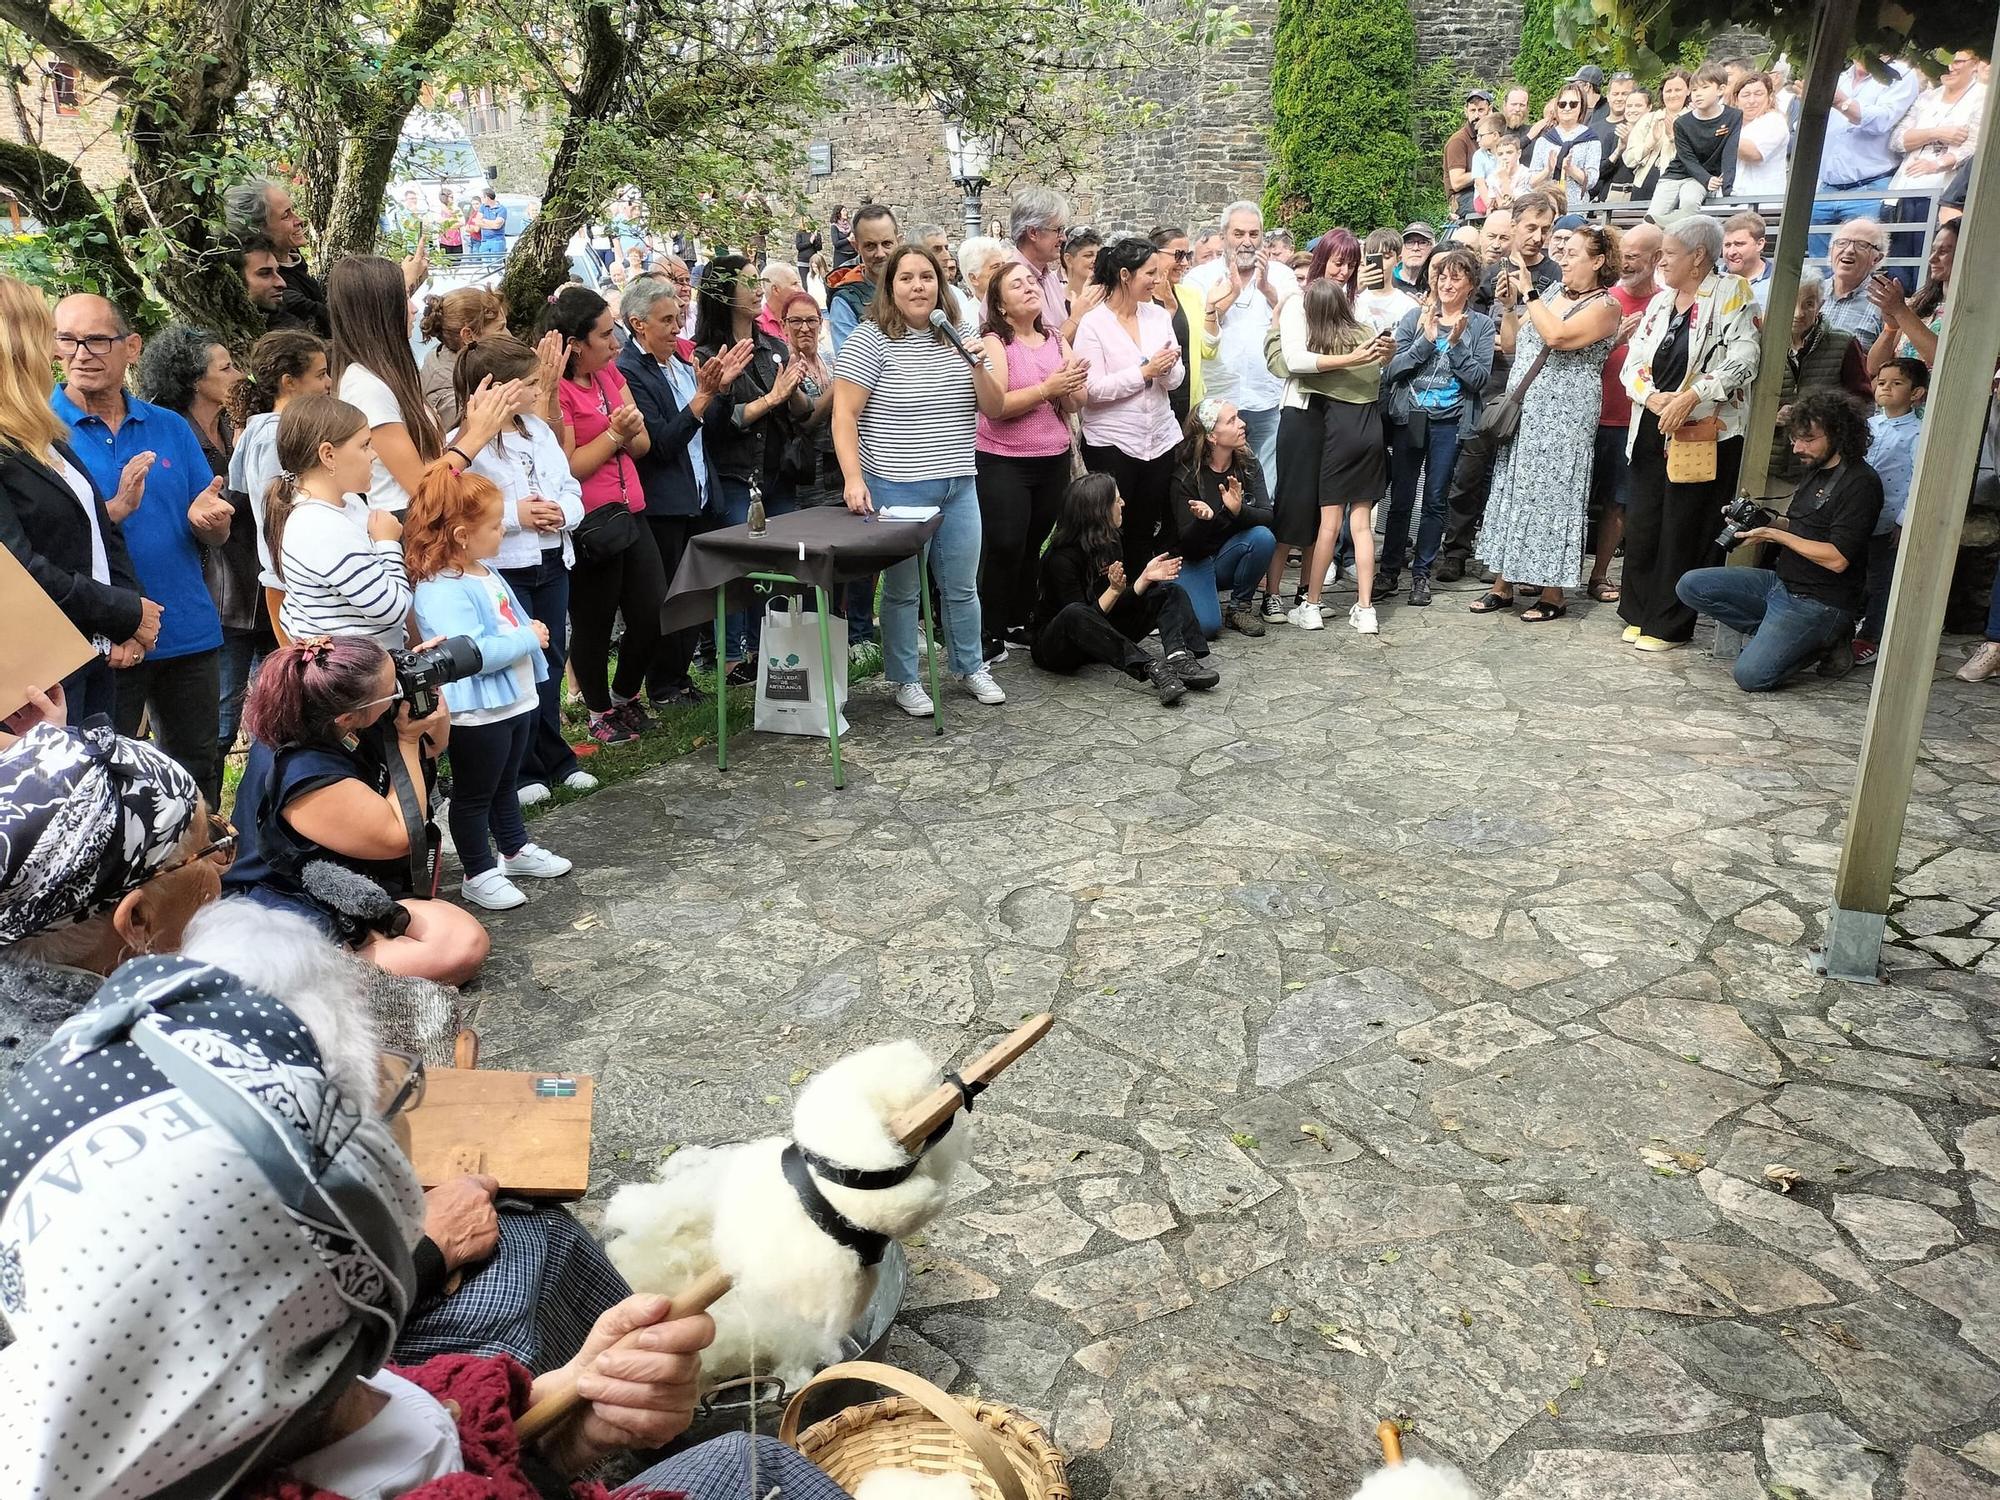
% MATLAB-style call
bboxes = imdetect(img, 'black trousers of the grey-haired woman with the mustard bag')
[1618,412,1744,640]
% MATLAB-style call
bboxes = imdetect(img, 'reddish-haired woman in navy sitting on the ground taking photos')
[224,636,492,984]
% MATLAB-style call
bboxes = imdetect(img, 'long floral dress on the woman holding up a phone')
[1480,286,1618,588]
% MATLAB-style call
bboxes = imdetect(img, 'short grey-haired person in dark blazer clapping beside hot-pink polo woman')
[618,276,752,704]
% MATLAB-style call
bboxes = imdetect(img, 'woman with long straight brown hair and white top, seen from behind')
[326,256,524,514]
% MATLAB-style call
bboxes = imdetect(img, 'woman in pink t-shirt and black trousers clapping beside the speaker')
[974,260,1084,664]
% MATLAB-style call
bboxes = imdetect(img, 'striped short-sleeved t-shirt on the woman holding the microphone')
[834,322,978,482]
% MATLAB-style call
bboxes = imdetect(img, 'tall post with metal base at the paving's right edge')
[1814,14,2000,984]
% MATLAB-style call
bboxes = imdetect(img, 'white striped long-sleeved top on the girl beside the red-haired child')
[278,496,410,648]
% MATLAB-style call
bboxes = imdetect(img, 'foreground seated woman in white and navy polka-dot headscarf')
[0,922,842,1500]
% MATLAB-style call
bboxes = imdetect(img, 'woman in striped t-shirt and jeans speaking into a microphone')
[834,244,1006,718]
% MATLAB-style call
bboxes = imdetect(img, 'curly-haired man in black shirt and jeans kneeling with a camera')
[1674,392,1882,692]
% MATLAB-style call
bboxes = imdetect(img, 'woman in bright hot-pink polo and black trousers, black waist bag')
[544,286,666,744]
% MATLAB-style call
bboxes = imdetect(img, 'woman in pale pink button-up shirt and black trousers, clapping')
[1076,234,1188,578]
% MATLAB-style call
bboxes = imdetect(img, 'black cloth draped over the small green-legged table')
[660,506,944,630]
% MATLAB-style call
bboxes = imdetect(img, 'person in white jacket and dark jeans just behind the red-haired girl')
[454,334,598,806]
